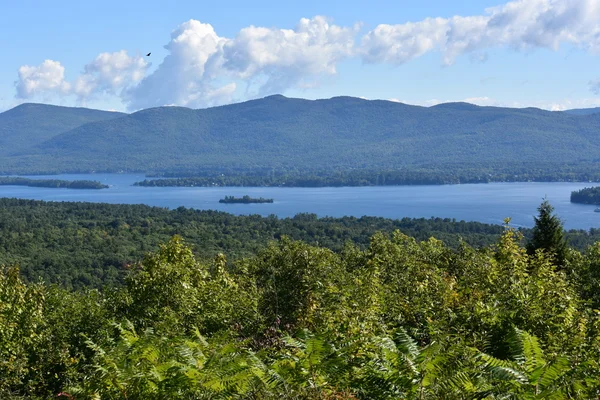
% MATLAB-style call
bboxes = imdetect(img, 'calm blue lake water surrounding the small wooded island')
[0,174,600,229]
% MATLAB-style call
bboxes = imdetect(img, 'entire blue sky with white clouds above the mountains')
[0,0,600,112]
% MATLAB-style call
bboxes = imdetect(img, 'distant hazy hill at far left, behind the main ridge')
[0,103,125,156]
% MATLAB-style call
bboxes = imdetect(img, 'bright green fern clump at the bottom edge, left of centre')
[69,323,270,400]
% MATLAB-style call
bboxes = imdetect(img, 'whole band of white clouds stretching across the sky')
[16,0,600,110]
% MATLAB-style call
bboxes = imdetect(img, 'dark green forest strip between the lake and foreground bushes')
[0,199,600,289]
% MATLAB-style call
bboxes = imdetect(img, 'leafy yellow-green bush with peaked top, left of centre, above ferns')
[113,236,254,333]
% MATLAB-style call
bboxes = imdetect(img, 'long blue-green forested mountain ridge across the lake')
[0,96,600,172]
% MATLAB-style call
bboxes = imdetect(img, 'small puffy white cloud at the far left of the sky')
[15,60,71,99]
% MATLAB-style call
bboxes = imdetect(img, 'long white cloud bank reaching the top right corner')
[361,0,600,64]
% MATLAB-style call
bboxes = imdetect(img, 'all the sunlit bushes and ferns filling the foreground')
[0,203,600,400]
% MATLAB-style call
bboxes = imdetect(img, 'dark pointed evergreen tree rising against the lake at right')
[527,199,567,265]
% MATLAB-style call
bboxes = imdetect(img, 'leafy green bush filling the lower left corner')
[0,268,107,398]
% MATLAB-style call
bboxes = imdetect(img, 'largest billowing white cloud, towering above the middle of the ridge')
[126,17,356,109]
